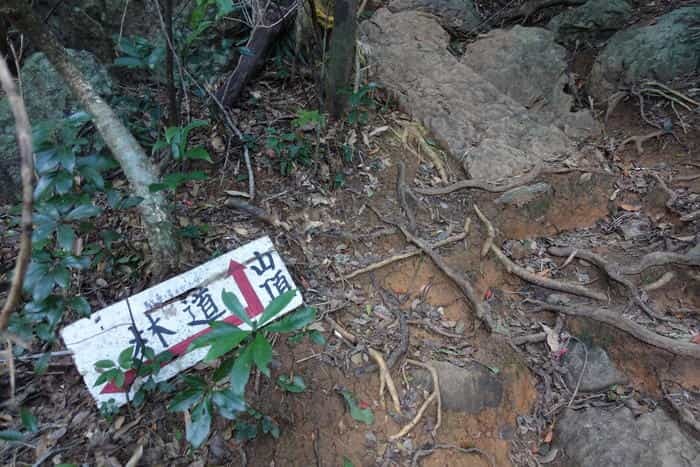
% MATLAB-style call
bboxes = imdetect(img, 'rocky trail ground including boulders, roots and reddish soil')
[0,0,700,467]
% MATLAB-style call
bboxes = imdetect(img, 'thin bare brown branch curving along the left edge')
[0,55,34,333]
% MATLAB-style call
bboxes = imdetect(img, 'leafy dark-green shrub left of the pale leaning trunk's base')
[10,112,135,348]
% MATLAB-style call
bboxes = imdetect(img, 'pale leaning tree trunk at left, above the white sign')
[5,0,179,277]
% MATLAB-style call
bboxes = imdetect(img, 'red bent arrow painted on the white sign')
[100,260,263,394]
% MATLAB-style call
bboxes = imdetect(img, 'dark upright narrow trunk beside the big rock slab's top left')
[325,0,357,119]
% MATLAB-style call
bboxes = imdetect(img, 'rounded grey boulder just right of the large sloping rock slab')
[462,26,599,138]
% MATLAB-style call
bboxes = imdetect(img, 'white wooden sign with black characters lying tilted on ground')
[61,237,302,405]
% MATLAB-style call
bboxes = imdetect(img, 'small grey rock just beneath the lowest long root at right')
[560,340,627,392]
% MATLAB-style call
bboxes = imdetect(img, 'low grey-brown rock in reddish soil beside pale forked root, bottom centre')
[415,361,503,414]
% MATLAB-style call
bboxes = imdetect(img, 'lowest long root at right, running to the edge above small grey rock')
[527,300,700,360]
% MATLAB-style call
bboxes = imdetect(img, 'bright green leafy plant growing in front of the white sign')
[94,290,316,448]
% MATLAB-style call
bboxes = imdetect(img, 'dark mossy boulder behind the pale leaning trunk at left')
[0,49,112,200]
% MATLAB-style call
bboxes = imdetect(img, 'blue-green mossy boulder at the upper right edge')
[589,6,700,100]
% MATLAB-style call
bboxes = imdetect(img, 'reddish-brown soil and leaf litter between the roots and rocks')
[0,1,700,466]
